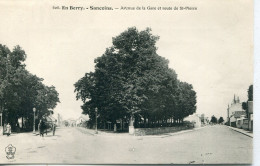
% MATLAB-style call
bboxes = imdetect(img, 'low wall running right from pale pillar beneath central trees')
[135,125,194,136]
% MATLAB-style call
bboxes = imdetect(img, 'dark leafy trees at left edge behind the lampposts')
[0,44,59,129]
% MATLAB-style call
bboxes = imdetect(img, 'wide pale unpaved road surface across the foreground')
[0,125,253,164]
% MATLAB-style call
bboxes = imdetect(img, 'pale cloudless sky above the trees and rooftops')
[0,0,253,119]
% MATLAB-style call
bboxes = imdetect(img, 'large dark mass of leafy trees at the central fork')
[74,27,196,127]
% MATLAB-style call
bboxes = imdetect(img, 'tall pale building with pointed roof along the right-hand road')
[227,95,246,127]
